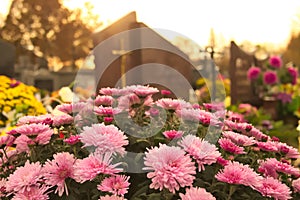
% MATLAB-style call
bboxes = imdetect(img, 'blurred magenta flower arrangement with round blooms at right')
[247,56,300,119]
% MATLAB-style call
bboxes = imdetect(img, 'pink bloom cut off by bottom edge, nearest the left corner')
[12,186,49,200]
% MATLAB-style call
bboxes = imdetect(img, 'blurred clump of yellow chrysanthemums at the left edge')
[0,75,46,128]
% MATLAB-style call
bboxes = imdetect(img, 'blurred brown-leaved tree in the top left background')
[0,0,100,70]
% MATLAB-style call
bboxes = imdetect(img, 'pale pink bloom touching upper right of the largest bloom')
[178,135,221,171]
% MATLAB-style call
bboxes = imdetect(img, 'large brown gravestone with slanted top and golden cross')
[93,12,192,100]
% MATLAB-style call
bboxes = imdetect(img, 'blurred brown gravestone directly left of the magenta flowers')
[229,41,263,106]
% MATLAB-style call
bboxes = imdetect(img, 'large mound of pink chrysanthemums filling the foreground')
[0,85,300,200]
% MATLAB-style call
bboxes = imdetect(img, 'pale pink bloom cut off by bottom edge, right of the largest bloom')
[179,187,216,200]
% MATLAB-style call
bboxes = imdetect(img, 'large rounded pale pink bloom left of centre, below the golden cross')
[80,123,128,155]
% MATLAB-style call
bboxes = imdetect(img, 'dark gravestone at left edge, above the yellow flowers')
[0,39,16,77]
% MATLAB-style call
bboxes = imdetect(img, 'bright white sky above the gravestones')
[0,0,300,46]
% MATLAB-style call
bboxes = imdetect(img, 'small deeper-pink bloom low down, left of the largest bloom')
[97,175,130,196]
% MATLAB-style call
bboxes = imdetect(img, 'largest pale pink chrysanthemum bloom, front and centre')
[143,144,196,193]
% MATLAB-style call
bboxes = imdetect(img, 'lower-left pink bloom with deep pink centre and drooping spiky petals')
[43,152,75,196]
